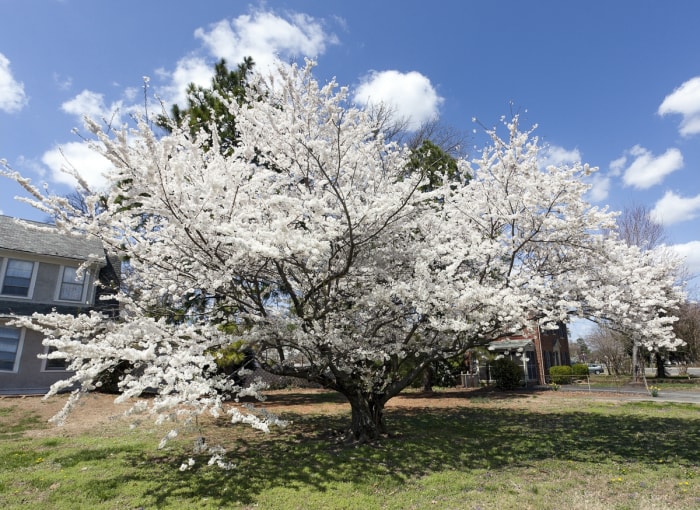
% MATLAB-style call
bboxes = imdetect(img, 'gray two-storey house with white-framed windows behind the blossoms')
[0,215,116,394]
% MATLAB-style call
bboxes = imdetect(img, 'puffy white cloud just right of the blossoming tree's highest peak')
[353,71,444,130]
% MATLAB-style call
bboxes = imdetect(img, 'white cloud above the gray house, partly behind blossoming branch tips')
[41,142,112,190]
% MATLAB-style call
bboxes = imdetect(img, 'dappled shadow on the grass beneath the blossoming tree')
[79,397,700,507]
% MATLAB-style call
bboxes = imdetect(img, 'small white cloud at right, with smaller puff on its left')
[610,145,683,189]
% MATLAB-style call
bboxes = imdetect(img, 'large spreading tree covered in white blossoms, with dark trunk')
[4,59,678,441]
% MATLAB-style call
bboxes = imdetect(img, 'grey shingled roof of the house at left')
[0,215,104,261]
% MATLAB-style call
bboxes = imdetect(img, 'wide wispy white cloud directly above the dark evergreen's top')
[194,11,338,70]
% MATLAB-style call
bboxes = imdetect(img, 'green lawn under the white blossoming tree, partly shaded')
[0,392,700,510]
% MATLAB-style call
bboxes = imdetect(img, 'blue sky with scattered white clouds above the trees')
[0,0,700,282]
